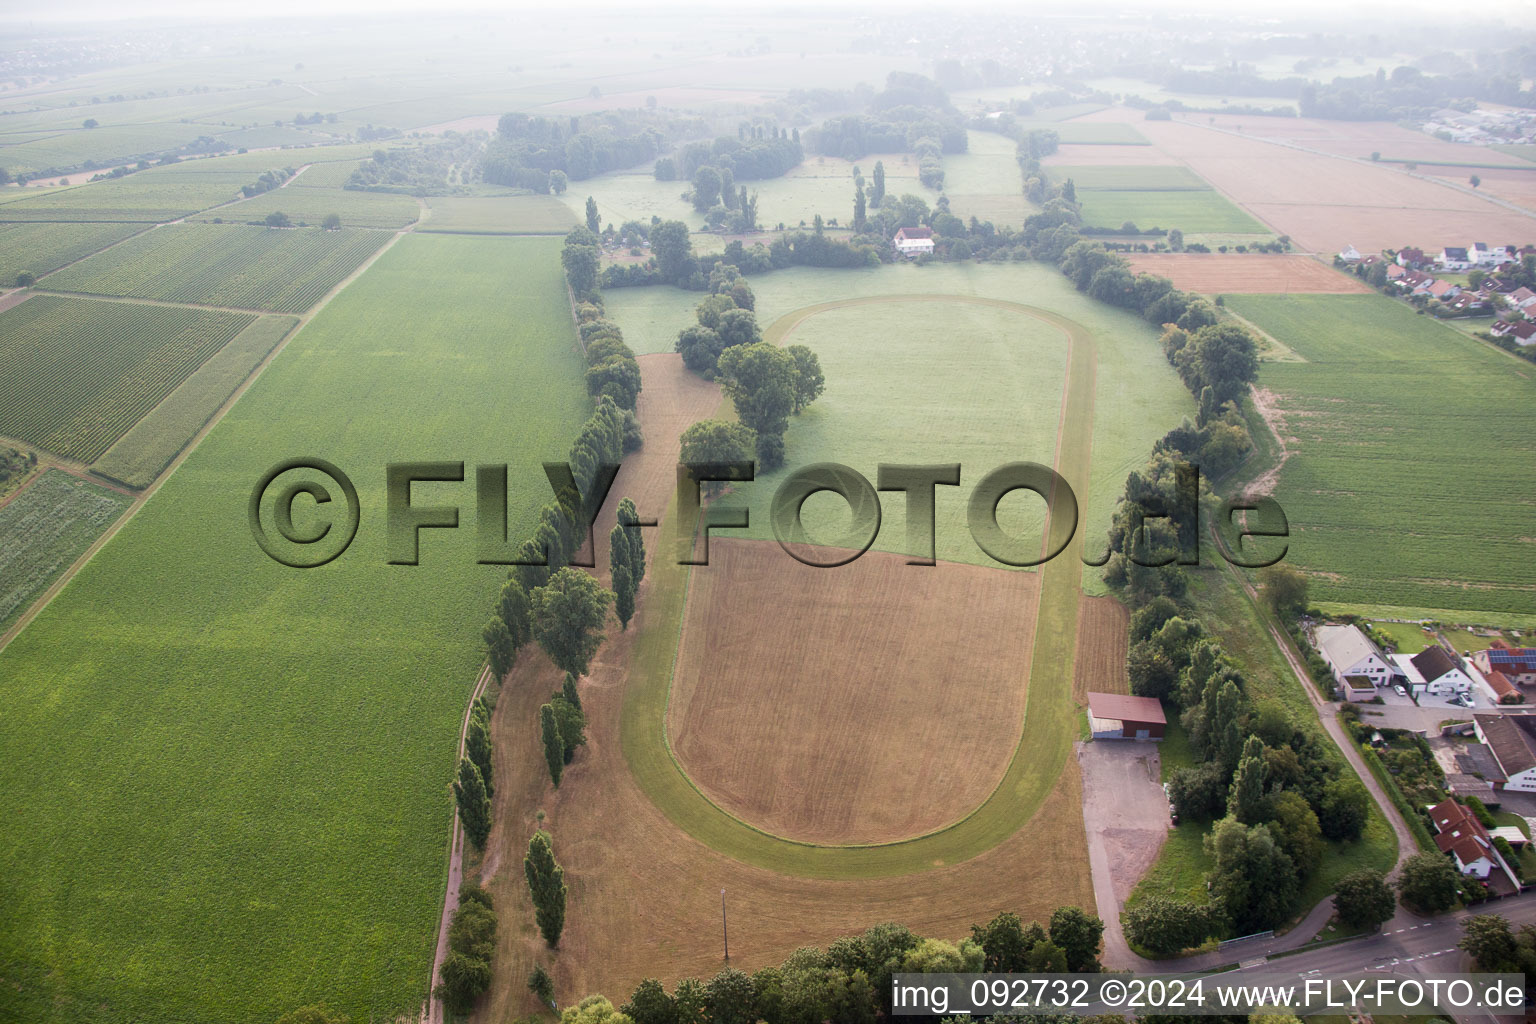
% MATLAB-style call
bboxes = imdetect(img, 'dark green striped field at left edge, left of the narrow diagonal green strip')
[0,295,255,462]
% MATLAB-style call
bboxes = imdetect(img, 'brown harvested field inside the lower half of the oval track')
[668,540,1040,844]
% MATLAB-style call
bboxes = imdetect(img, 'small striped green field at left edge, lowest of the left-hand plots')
[0,470,132,633]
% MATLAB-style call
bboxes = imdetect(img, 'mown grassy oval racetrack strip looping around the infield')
[619,295,1097,878]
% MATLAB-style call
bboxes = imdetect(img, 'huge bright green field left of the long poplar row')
[0,236,590,1024]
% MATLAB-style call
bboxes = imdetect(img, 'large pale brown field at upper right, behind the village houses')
[1084,109,1536,253]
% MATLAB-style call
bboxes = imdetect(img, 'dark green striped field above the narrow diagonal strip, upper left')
[43,224,390,313]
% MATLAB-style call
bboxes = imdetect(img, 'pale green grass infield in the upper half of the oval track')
[717,296,1068,565]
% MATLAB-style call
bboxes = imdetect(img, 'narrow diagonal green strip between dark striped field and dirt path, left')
[91,316,298,488]
